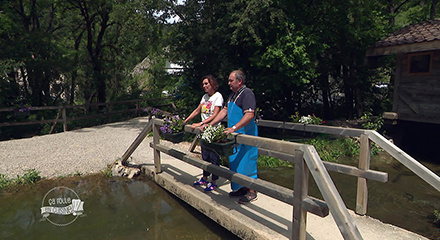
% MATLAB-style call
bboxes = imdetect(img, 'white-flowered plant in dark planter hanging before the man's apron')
[202,125,236,156]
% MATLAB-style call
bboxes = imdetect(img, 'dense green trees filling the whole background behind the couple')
[0,0,439,129]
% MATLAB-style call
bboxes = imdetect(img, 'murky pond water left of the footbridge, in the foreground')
[0,174,238,239]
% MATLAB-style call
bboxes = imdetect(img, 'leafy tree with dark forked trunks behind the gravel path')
[59,0,163,102]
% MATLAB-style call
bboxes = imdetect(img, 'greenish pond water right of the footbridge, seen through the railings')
[258,158,440,239]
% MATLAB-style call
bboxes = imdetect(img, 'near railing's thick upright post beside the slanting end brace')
[292,150,310,240]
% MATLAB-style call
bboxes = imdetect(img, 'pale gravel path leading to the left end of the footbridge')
[0,117,196,178]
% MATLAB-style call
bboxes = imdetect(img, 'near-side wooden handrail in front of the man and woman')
[151,119,362,239]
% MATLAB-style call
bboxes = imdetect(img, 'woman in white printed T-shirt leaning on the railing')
[183,75,223,192]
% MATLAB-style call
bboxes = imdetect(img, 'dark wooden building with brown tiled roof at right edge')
[367,20,440,124]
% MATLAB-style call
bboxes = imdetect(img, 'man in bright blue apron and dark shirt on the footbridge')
[210,70,258,204]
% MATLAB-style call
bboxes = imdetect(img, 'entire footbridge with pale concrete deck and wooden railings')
[122,118,440,239]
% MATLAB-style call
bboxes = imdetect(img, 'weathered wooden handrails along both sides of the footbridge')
[124,119,440,239]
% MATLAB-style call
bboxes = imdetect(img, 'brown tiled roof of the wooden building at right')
[367,20,440,56]
